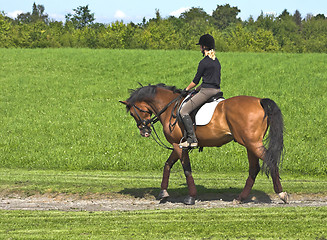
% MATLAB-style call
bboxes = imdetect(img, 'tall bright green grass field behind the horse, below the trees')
[0,49,327,175]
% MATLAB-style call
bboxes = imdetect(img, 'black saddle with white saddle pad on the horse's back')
[177,91,225,126]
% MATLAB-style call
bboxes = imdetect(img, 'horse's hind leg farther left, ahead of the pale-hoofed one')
[234,149,260,203]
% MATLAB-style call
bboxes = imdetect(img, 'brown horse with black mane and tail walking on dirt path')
[120,84,289,205]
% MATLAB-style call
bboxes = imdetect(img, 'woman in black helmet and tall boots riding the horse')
[180,34,221,148]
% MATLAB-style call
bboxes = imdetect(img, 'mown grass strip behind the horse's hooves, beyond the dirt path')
[0,169,327,199]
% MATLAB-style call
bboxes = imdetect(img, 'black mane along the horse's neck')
[127,83,182,105]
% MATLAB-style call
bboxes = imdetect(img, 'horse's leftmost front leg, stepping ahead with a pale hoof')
[157,145,182,200]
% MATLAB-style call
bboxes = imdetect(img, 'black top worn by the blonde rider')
[193,56,221,89]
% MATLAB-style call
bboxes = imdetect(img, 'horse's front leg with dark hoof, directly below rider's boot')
[181,149,196,205]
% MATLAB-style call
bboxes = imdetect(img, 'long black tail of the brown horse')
[260,98,284,176]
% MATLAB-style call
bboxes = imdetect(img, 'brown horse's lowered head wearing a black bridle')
[119,101,152,137]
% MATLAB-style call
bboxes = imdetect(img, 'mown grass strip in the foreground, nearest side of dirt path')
[0,207,327,240]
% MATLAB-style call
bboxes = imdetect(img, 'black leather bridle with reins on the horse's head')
[132,95,182,150]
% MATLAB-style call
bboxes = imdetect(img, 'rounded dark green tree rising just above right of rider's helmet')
[212,4,241,29]
